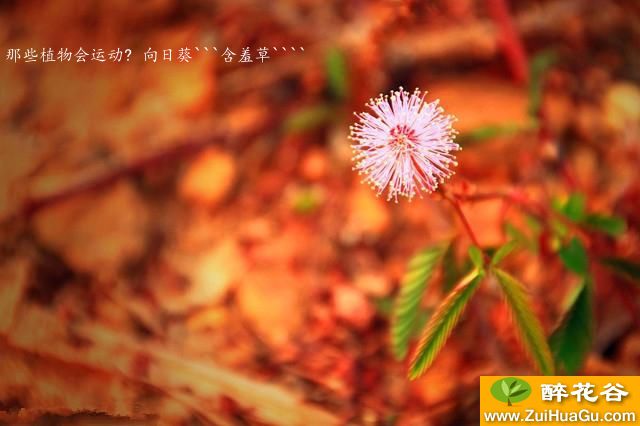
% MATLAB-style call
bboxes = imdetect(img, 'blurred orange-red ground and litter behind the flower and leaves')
[0,0,640,425]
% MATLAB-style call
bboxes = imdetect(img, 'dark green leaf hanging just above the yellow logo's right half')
[549,277,594,374]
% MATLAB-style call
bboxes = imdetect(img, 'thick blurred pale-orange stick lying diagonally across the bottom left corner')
[6,303,340,426]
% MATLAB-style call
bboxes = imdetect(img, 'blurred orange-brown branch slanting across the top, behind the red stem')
[219,0,622,99]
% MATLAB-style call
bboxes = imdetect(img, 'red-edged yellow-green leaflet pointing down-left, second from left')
[409,269,484,380]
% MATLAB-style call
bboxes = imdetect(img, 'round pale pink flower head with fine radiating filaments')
[349,87,460,202]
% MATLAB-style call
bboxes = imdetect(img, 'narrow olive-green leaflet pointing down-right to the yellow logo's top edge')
[494,269,553,375]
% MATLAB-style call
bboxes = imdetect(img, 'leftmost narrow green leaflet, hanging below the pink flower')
[391,244,446,359]
